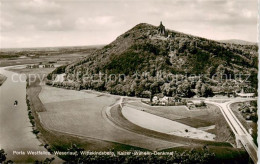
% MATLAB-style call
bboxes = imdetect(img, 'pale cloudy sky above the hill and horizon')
[0,0,257,48]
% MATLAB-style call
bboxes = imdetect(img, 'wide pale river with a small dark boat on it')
[0,67,52,163]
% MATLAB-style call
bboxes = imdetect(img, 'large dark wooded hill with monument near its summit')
[48,23,258,97]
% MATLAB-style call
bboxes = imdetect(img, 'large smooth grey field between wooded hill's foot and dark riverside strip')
[38,86,183,150]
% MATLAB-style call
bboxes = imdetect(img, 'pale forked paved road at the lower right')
[205,98,257,163]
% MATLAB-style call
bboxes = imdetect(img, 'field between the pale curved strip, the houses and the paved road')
[124,99,234,144]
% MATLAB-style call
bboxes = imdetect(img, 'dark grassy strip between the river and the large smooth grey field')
[24,73,153,160]
